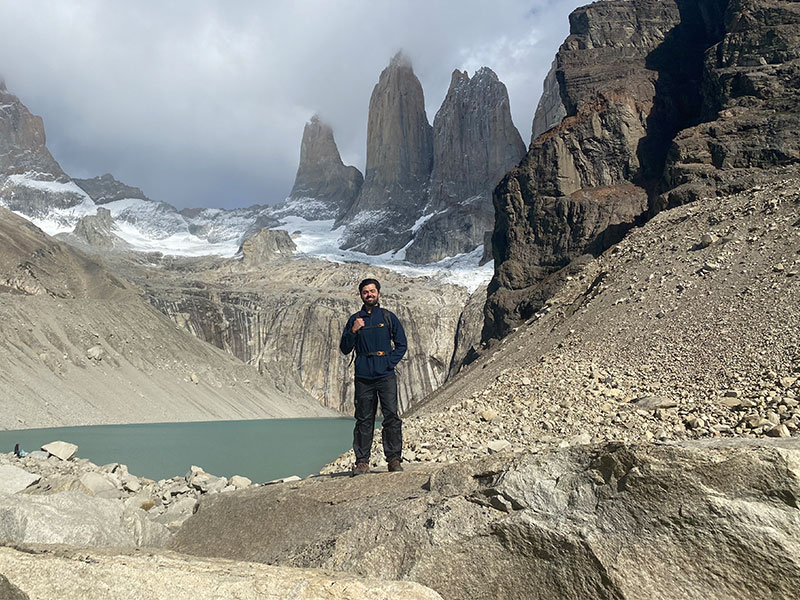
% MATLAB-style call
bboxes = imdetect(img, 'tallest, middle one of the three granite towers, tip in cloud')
[339,53,433,254]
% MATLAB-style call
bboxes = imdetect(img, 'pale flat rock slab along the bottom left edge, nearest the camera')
[0,548,441,600]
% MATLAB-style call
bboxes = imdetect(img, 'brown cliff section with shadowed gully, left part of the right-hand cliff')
[483,0,748,338]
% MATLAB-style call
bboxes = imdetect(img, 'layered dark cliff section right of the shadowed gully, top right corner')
[652,0,800,212]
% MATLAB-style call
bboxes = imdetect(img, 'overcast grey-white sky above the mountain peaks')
[0,0,586,208]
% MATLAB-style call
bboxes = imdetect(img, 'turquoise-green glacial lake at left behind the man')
[0,418,354,482]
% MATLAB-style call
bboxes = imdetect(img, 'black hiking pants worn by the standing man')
[353,374,403,463]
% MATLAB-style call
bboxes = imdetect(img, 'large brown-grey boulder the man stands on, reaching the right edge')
[171,439,800,600]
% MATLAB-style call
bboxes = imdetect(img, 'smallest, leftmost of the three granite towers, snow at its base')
[279,115,364,219]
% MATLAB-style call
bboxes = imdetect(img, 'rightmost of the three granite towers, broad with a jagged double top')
[406,67,525,263]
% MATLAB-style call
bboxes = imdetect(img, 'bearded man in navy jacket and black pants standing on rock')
[339,279,407,475]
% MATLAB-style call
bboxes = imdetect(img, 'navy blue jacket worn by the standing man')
[339,305,408,379]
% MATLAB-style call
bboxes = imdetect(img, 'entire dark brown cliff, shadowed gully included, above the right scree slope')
[483,0,780,338]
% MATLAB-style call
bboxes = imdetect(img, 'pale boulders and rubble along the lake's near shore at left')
[0,441,278,547]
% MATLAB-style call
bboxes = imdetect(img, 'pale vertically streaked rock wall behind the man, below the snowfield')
[135,260,467,414]
